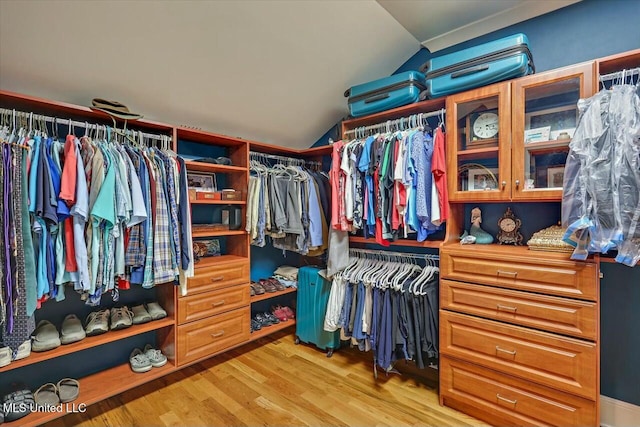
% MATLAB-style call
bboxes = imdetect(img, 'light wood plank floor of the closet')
[47,332,485,427]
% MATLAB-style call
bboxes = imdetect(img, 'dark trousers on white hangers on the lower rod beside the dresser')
[324,250,439,371]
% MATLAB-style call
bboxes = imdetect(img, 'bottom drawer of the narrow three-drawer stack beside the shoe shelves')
[178,307,251,365]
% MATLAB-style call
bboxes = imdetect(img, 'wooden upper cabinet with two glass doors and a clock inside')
[447,63,594,202]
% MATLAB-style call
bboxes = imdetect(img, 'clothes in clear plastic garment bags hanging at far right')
[562,84,640,267]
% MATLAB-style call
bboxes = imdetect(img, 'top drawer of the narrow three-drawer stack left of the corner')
[187,262,249,295]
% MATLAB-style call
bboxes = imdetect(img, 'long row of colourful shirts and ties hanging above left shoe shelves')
[0,113,193,352]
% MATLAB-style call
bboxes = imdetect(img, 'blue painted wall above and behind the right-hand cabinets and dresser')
[314,0,640,405]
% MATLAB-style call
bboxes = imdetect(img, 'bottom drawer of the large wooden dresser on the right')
[440,357,598,427]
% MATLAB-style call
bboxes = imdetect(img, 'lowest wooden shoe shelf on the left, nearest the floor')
[3,361,178,427]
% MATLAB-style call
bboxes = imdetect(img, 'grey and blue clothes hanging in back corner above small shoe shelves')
[246,154,329,256]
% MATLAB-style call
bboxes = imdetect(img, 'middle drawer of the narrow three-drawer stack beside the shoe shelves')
[178,284,251,324]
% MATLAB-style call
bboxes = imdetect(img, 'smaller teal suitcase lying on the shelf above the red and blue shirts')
[344,71,425,117]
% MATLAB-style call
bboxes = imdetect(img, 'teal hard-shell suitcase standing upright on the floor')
[296,266,340,357]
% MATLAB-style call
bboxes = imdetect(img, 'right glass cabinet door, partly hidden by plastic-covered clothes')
[511,63,593,201]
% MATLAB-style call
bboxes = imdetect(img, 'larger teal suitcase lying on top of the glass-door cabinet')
[421,33,535,98]
